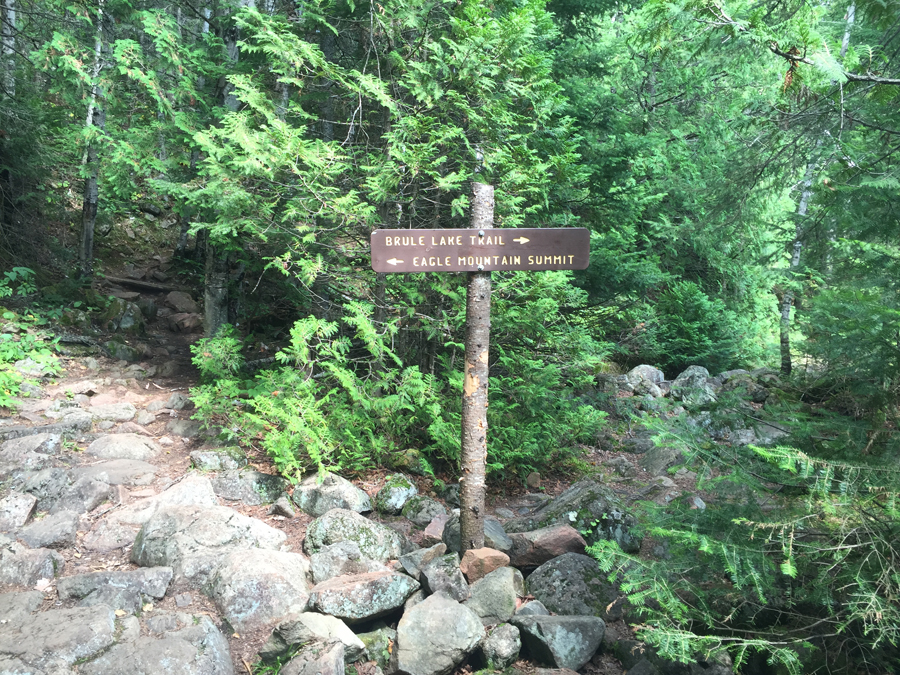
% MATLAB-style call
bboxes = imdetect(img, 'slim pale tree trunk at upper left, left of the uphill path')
[79,8,106,277]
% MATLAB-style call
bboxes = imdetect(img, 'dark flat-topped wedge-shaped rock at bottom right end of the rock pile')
[511,616,606,670]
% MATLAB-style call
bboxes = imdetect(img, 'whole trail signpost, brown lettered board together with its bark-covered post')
[371,183,590,553]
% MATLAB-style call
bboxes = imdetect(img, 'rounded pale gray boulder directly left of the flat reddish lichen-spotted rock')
[207,549,309,633]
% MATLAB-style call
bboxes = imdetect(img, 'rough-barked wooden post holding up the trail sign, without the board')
[459,183,494,553]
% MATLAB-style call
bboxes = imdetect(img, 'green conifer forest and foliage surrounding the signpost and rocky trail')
[0,0,900,672]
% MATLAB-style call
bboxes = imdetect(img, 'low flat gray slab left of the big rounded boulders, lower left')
[56,567,172,614]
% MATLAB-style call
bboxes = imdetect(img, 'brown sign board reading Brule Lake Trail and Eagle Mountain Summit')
[371,227,591,272]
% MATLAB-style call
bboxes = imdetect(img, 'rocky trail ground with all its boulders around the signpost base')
[0,284,780,675]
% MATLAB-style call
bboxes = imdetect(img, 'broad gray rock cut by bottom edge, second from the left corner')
[78,612,234,675]
